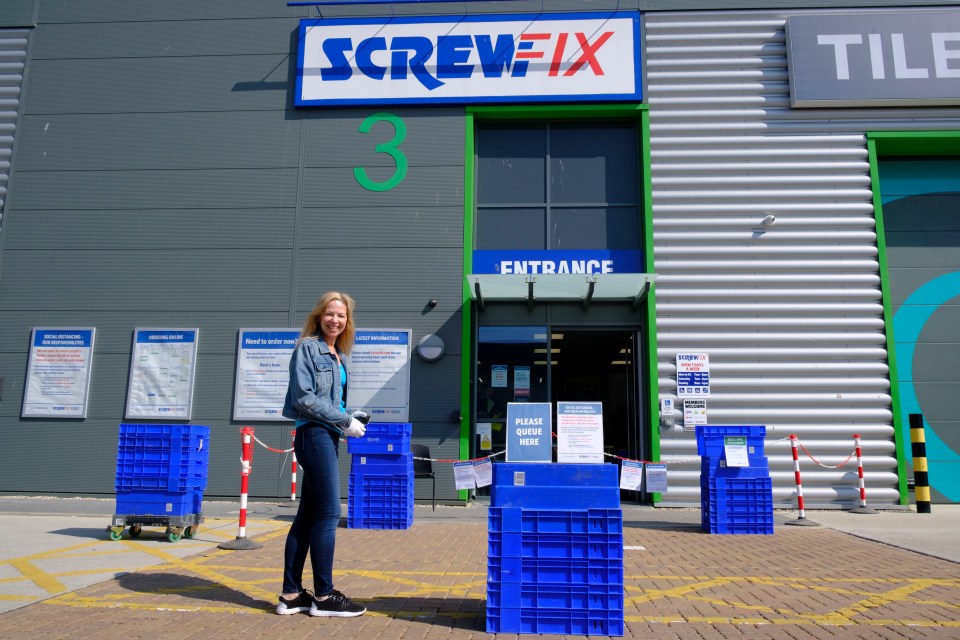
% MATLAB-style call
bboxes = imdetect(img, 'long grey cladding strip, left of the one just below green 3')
[4,208,295,250]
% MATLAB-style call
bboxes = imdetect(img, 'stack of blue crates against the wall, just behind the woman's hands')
[347,422,413,529]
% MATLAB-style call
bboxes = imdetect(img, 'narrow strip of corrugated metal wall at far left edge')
[0,29,30,230]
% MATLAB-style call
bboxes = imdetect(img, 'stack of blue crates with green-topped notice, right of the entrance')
[697,425,773,534]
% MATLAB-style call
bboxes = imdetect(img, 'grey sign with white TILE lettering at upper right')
[786,10,960,107]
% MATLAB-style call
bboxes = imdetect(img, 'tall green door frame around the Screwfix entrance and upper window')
[459,104,660,501]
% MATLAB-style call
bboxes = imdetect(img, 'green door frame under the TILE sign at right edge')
[867,131,960,505]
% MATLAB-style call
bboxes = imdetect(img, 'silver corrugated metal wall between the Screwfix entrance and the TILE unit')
[644,9,960,506]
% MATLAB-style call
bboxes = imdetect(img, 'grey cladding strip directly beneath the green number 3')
[299,206,463,249]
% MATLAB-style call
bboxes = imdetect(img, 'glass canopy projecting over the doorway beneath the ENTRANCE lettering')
[466,273,656,309]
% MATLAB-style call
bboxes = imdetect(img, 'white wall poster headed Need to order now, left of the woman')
[233,329,300,420]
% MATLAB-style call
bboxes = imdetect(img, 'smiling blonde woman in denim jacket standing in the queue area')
[277,291,369,617]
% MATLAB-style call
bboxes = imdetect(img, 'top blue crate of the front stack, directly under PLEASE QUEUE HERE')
[490,462,620,510]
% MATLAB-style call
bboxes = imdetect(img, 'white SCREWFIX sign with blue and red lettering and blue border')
[295,12,642,106]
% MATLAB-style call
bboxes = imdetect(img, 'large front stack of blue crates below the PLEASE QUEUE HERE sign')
[487,462,624,636]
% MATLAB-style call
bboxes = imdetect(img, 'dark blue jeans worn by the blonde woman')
[283,422,340,596]
